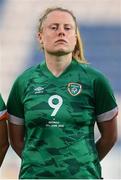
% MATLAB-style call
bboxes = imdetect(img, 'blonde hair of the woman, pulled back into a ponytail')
[38,7,87,63]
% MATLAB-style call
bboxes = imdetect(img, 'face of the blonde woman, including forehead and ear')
[38,11,76,56]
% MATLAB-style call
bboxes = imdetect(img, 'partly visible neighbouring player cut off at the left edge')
[0,94,9,166]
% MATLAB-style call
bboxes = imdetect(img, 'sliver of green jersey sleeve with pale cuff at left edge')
[0,94,7,120]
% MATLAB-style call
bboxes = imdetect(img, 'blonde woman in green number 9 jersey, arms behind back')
[8,8,117,179]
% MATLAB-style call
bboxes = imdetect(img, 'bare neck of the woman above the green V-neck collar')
[45,54,72,77]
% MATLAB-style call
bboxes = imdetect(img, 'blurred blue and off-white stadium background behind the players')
[0,0,121,179]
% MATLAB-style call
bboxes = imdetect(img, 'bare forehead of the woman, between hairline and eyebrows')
[44,10,75,25]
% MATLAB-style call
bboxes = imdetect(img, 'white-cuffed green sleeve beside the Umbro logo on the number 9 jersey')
[7,67,36,125]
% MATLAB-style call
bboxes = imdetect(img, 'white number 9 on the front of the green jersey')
[48,95,63,116]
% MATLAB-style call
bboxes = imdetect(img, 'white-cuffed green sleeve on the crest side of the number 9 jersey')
[94,74,118,122]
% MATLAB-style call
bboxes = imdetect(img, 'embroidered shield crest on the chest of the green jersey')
[68,83,82,96]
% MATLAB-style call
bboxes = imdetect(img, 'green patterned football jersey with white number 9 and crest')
[7,60,117,179]
